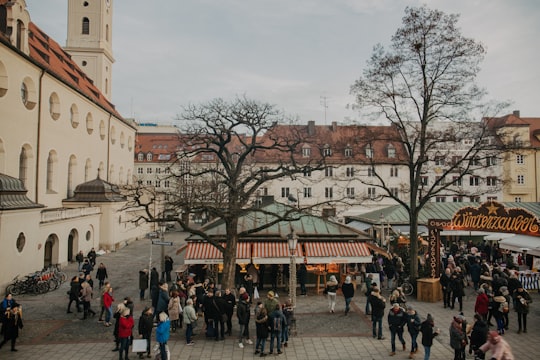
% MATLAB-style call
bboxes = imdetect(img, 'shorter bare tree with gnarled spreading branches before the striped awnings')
[168,98,324,287]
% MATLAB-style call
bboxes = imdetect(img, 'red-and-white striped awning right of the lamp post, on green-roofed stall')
[304,241,371,264]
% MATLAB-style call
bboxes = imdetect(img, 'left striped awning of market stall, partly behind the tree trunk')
[184,242,251,264]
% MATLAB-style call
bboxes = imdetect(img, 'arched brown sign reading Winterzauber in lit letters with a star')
[449,201,540,236]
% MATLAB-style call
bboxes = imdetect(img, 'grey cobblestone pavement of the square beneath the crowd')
[0,232,540,360]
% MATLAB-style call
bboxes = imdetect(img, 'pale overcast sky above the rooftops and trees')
[26,0,540,124]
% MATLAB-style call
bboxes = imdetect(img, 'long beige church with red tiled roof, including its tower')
[0,0,145,290]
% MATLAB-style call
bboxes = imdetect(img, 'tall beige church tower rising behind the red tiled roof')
[65,0,114,101]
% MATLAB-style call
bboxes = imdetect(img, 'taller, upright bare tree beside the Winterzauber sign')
[351,6,508,278]
